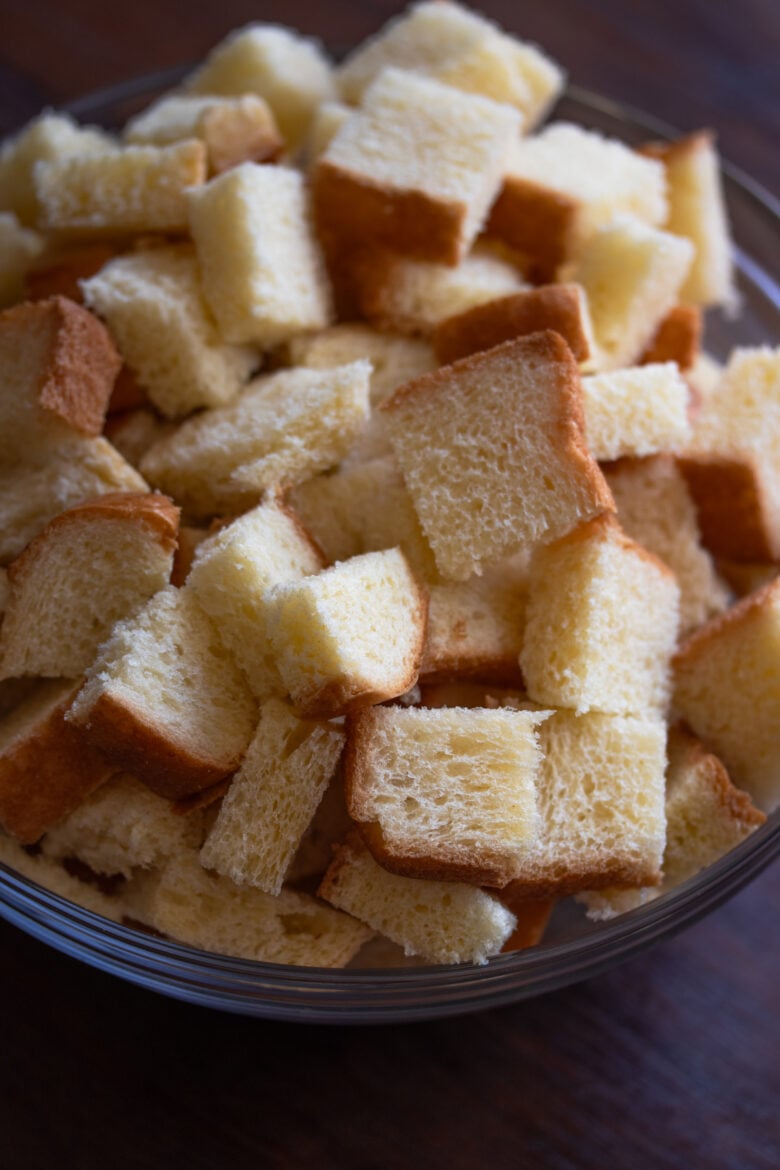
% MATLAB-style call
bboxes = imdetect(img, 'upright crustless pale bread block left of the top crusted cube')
[188,163,331,349]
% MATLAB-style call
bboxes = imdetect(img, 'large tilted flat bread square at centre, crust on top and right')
[381,332,614,580]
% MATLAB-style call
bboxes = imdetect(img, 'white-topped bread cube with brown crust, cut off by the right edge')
[682,346,780,562]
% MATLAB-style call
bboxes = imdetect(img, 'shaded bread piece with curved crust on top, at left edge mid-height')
[0,493,179,679]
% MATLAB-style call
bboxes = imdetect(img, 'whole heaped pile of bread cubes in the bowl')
[0,2,780,966]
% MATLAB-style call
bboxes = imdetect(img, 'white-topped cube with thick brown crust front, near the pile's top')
[313,69,520,264]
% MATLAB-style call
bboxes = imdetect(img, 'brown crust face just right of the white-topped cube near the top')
[486,174,579,283]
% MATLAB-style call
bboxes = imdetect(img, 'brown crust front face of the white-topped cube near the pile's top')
[312,159,467,264]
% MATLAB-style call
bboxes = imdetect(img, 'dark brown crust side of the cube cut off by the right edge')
[678,454,780,562]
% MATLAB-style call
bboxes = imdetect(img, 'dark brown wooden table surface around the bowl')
[0,0,780,1170]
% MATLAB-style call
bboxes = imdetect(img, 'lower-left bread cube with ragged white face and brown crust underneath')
[68,586,256,799]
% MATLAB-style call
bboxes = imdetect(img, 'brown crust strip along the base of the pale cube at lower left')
[71,691,241,800]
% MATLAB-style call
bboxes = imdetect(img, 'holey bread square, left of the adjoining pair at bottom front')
[344,707,546,888]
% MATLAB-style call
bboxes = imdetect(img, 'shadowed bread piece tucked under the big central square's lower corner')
[420,556,527,682]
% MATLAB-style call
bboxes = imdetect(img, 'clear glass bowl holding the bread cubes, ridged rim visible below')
[0,69,780,1024]
